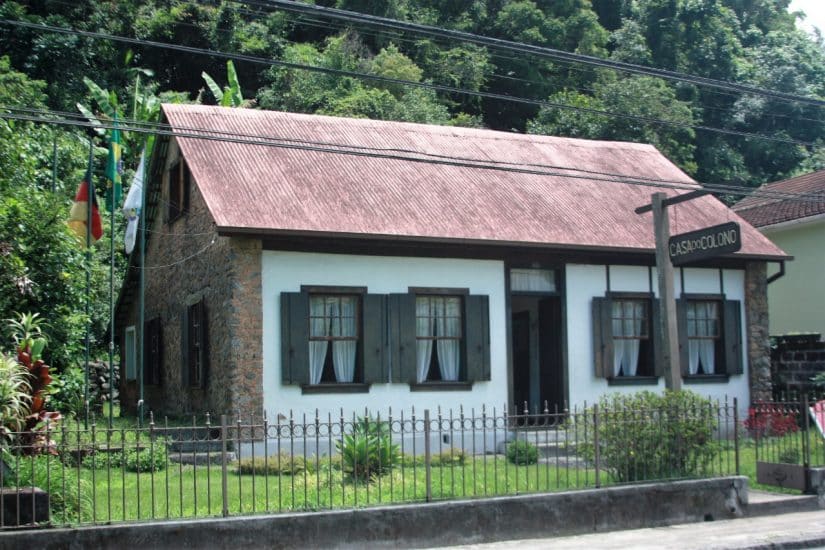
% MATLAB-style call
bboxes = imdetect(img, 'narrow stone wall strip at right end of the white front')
[745,262,771,402]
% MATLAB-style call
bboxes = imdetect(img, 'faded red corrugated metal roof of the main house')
[163,105,784,257]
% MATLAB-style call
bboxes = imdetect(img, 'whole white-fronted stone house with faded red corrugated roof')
[117,105,786,418]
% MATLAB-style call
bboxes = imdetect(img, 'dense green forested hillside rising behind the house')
[0,0,825,366]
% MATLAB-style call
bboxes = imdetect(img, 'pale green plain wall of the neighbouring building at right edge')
[762,217,825,334]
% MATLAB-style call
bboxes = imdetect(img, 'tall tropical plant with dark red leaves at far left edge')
[6,313,61,454]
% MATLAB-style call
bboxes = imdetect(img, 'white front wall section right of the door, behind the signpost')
[565,264,749,412]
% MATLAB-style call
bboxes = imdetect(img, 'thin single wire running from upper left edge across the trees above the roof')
[0,19,816,147]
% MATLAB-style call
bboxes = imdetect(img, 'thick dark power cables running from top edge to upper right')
[248,0,825,107]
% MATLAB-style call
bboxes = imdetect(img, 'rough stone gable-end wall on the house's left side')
[119,143,263,415]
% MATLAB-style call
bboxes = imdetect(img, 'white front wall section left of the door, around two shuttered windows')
[261,251,507,418]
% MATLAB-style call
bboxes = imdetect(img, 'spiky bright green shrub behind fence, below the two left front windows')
[335,417,401,480]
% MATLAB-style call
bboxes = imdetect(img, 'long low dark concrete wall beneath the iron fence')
[0,477,747,550]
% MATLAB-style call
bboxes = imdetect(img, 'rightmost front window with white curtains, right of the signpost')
[686,300,722,375]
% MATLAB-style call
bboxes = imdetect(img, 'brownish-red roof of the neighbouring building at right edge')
[733,170,825,227]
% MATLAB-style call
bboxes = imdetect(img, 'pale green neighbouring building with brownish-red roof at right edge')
[733,170,825,335]
